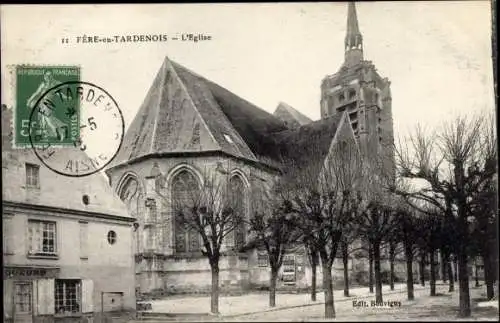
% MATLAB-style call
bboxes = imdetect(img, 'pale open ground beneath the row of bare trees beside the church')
[128,284,498,323]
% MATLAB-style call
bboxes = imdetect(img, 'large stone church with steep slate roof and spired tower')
[106,3,393,293]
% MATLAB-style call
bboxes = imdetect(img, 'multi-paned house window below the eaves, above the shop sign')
[28,220,57,255]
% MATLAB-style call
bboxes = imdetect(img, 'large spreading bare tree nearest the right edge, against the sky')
[396,117,496,317]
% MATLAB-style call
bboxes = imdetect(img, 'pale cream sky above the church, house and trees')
[0,1,494,141]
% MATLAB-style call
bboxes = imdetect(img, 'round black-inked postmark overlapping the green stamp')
[29,81,125,177]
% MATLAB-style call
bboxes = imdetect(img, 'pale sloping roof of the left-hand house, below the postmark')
[2,105,130,218]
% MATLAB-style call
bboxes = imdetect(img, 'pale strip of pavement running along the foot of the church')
[150,284,428,317]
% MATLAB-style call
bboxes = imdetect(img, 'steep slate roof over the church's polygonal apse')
[106,57,348,175]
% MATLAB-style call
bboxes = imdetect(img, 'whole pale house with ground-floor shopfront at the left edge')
[2,106,135,322]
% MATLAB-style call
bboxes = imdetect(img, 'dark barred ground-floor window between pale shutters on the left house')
[55,279,82,314]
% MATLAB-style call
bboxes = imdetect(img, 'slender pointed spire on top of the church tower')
[344,1,363,65]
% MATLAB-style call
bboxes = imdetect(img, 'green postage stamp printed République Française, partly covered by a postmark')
[14,65,80,148]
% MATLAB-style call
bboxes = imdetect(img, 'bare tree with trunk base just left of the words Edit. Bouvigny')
[286,139,362,318]
